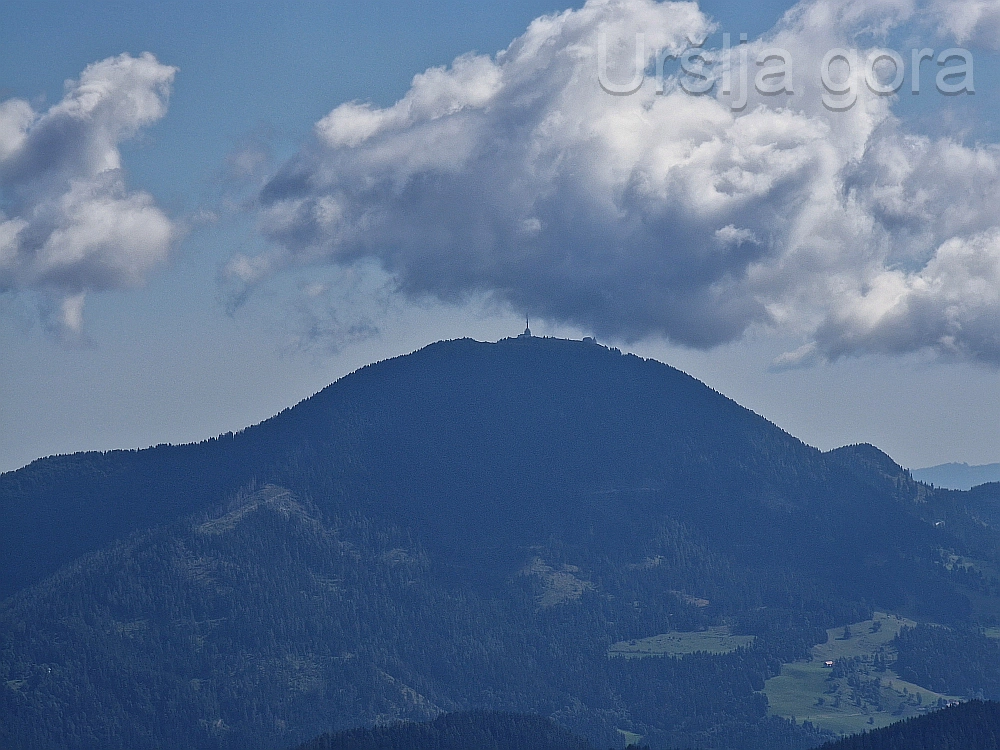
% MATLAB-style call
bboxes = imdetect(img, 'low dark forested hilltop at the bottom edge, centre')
[296,711,594,750]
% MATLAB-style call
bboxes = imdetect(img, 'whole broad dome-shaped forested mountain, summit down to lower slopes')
[0,338,1000,750]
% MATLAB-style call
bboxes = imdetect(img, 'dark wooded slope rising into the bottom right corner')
[822,701,1000,750]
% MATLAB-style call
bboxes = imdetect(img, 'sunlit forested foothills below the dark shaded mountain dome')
[0,486,828,750]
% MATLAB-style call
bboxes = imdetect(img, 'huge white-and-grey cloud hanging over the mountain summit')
[240,0,1000,367]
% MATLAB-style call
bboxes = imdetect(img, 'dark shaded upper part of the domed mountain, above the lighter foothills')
[0,338,994,599]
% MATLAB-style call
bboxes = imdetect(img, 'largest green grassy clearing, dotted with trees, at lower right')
[764,613,956,734]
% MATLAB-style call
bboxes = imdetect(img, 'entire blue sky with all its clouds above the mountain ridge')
[0,0,1000,471]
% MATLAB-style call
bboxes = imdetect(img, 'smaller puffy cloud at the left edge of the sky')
[0,53,176,334]
